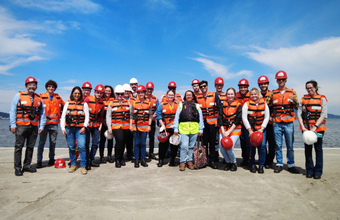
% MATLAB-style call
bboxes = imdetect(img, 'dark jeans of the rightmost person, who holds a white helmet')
[305,131,324,176]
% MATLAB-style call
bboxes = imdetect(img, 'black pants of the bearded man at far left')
[14,125,38,169]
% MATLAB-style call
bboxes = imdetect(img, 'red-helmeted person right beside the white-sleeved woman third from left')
[84,84,105,170]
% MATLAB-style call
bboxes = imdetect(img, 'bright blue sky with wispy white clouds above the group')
[0,0,340,114]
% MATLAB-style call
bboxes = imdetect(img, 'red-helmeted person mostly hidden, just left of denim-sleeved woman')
[145,82,159,159]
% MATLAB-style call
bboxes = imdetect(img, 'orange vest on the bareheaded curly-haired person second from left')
[40,92,65,125]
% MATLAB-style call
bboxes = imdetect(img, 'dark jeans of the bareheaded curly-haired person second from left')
[37,125,58,162]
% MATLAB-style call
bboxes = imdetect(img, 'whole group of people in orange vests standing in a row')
[10,70,327,179]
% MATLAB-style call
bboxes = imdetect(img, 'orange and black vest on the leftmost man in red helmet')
[16,92,41,126]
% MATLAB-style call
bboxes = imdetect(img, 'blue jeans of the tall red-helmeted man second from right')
[274,122,295,168]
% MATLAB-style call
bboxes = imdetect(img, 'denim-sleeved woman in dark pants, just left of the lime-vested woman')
[156,90,178,167]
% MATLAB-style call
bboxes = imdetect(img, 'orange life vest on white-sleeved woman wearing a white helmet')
[110,99,130,129]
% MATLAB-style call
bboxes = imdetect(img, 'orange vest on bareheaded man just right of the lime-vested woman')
[197,92,218,125]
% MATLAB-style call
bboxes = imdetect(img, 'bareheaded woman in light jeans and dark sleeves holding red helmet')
[218,88,242,171]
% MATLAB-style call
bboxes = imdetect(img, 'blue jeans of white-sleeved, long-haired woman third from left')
[66,127,86,167]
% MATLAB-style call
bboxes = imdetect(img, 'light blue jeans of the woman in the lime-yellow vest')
[180,134,198,163]
